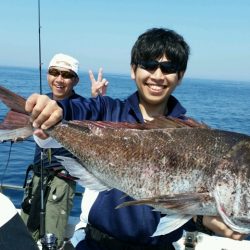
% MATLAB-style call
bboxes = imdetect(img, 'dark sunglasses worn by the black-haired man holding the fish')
[138,61,178,74]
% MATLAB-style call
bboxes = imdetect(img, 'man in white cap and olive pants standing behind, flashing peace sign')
[21,53,107,247]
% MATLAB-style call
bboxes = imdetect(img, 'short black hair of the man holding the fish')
[131,28,190,72]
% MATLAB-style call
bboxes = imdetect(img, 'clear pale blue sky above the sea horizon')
[0,0,250,81]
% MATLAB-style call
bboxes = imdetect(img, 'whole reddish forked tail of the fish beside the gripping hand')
[0,86,33,142]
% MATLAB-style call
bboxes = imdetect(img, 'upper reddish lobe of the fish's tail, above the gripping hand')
[0,86,28,114]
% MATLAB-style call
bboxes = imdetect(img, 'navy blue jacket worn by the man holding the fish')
[59,92,195,245]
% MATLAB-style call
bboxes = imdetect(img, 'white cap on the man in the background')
[49,53,79,75]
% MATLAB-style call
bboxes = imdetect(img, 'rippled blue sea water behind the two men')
[0,67,250,215]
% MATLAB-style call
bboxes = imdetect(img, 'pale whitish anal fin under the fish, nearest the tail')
[55,155,110,192]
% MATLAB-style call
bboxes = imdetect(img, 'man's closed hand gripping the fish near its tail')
[25,94,63,139]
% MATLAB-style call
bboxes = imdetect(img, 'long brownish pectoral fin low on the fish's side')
[117,192,212,214]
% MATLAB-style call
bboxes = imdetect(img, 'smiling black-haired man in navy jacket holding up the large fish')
[26,28,243,250]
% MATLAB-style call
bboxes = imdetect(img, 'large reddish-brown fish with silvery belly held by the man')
[0,87,250,234]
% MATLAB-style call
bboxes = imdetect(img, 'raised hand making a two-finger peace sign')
[89,68,108,97]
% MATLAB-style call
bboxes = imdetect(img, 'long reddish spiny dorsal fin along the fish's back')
[68,117,207,130]
